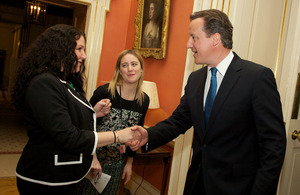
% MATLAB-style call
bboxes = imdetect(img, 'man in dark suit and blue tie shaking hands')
[132,10,286,195]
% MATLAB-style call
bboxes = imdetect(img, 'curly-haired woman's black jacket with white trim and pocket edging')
[17,73,96,186]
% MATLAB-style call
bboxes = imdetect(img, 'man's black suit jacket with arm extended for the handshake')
[143,54,286,195]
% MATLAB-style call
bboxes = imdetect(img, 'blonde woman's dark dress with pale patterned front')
[78,84,149,195]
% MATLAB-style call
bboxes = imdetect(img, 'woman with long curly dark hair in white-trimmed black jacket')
[11,24,139,194]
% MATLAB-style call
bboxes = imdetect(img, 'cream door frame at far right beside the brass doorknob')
[278,0,300,195]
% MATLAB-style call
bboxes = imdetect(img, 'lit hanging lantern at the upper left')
[25,1,47,24]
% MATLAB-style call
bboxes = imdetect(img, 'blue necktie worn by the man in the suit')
[204,68,217,126]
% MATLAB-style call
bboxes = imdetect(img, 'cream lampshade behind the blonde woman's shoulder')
[142,81,159,109]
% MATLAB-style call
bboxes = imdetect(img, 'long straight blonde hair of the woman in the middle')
[108,49,144,105]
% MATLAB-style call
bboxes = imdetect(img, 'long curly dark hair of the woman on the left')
[11,24,86,110]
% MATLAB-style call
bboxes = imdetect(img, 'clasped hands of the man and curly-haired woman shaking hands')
[117,125,148,151]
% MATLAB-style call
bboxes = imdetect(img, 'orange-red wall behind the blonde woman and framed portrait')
[98,0,193,189]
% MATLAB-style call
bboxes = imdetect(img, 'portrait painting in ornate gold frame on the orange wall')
[133,0,170,59]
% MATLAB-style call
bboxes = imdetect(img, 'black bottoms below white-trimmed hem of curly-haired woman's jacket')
[17,177,76,195]
